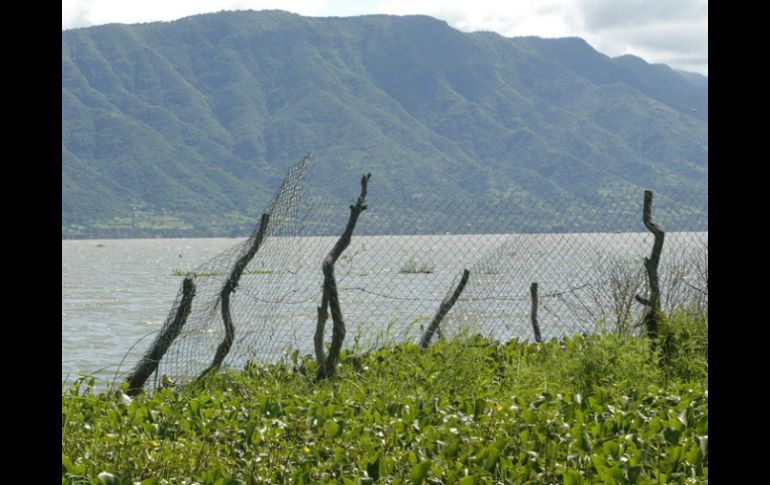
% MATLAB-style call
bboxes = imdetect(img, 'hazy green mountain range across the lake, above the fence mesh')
[62,11,708,237]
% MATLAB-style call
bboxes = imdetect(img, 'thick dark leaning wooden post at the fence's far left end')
[127,276,195,396]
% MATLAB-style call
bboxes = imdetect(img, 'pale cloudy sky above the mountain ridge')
[62,0,708,76]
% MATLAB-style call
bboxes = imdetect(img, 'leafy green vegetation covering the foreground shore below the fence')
[62,314,708,485]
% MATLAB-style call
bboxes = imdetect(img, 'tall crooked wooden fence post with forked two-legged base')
[313,173,372,379]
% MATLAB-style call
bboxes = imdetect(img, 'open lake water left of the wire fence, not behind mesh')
[62,239,241,380]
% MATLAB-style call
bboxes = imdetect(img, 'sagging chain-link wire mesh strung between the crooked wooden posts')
[127,157,708,387]
